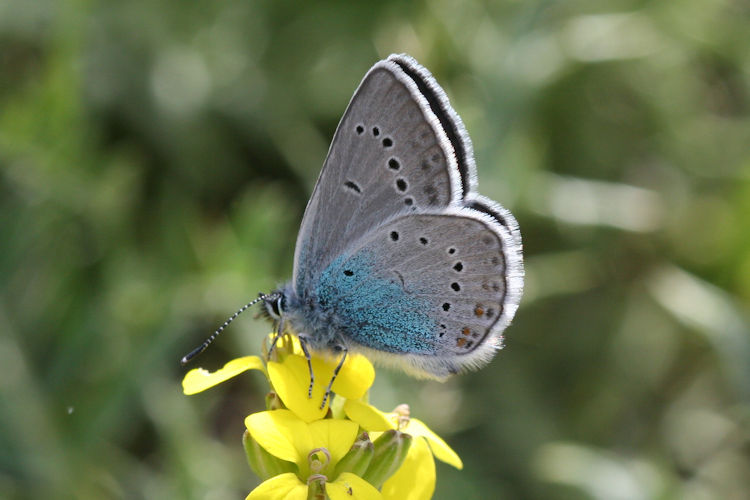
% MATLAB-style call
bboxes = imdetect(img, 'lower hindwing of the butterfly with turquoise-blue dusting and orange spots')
[316,201,523,378]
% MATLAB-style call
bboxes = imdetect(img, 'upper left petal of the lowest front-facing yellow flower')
[245,410,313,466]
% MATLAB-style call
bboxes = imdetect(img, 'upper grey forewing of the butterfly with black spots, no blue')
[293,55,475,293]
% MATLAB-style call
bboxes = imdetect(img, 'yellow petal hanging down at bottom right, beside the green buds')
[381,438,435,500]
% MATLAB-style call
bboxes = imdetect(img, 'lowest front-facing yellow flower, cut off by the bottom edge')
[245,410,382,500]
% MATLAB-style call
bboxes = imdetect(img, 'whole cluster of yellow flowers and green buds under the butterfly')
[182,335,463,500]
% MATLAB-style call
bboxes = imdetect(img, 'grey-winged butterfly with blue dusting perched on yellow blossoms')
[184,54,524,405]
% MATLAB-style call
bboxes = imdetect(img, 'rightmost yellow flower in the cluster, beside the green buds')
[344,399,463,500]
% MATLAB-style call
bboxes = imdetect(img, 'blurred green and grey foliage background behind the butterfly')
[0,0,750,500]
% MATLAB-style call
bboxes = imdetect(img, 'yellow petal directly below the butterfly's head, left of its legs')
[268,356,333,422]
